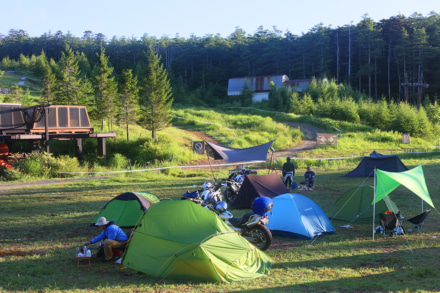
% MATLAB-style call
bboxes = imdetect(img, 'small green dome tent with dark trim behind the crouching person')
[93,191,159,228]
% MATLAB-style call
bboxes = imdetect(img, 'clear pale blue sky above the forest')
[0,0,440,39]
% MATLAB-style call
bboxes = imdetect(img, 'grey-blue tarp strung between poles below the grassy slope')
[205,140,274,163]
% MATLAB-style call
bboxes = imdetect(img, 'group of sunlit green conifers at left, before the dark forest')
[0,45,173,141]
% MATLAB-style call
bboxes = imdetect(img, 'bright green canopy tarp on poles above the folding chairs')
[371,165,435,239]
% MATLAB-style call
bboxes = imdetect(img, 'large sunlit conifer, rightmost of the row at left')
[137,49,173,140]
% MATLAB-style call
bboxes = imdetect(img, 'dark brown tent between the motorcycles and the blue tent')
[230,173,289,209]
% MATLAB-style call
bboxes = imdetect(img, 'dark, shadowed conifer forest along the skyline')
[0,12,440,105]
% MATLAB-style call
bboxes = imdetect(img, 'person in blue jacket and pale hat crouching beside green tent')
[84,217,128,261]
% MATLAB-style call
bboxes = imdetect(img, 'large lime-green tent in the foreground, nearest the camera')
[121,200,272,283]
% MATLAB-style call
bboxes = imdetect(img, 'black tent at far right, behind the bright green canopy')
[344,151,408,177]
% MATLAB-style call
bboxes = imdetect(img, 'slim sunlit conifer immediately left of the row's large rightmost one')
[119,69,139,141]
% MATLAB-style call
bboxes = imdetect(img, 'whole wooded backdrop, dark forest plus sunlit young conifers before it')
[0,13,440,154]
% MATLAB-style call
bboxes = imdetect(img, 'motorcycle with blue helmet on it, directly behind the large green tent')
[206,197,273,251]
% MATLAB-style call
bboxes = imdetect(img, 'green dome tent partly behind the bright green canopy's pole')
[327,185,399,223]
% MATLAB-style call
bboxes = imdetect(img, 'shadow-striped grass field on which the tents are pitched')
[0,156,440,292]
